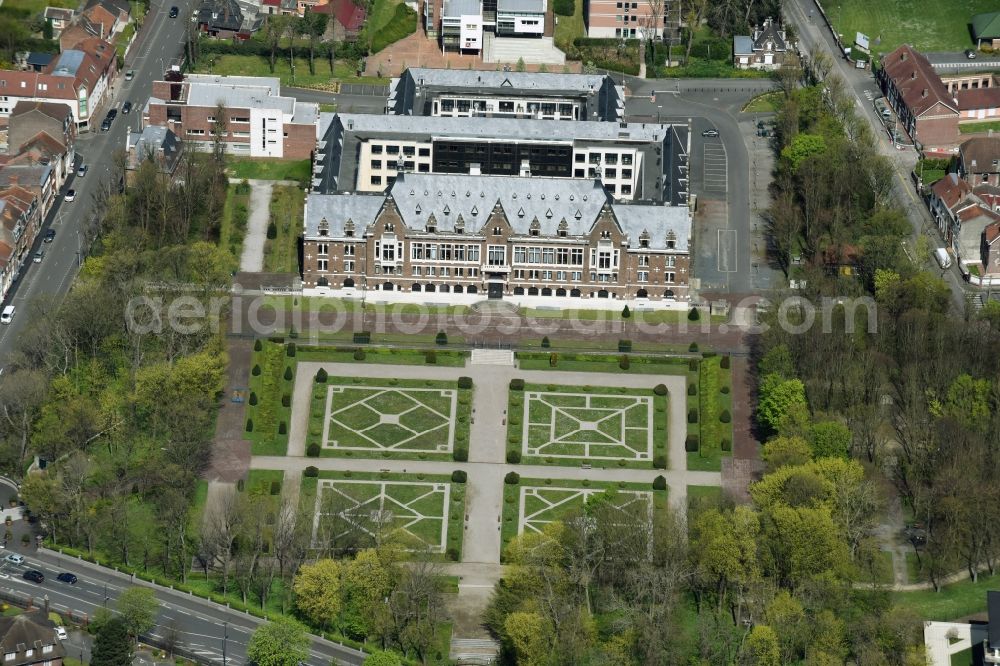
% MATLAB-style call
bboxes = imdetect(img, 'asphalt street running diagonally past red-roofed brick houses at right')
[785,0,969,313]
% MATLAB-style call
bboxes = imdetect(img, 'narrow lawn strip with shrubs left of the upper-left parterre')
[245,340,296,456]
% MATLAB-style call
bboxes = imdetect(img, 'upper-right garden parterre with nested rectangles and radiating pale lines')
[507,384,668,469]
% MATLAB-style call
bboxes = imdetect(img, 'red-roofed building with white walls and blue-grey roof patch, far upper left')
[0,39,116,127]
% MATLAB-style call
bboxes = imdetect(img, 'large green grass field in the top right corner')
[823,0,997,53]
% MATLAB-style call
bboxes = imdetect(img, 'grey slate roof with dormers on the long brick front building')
[305,173,691,252]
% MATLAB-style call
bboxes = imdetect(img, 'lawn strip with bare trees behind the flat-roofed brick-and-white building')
[195,53,356,89]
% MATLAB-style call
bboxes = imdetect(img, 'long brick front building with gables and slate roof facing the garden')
[303,173,691,306]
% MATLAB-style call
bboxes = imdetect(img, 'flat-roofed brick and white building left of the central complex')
[143,72,319,159]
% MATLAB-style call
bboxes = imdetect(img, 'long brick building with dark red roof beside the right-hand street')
[876,44,959,151]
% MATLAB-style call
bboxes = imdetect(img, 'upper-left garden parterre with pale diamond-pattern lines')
[307,377,472,460]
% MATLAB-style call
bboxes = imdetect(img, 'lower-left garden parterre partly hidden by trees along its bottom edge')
[301,470,465,560]
